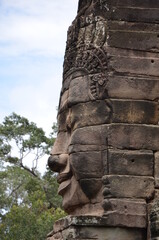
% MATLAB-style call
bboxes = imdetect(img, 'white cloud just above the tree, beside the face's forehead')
[9,79,60,130]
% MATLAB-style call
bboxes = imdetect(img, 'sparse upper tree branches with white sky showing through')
[0,113,54,172]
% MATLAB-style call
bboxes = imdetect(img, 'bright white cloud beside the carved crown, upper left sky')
[0,17,66,56]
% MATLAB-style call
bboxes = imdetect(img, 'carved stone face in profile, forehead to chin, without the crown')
[49,70,111,213]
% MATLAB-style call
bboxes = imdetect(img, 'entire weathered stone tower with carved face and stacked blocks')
[48,0,159,240]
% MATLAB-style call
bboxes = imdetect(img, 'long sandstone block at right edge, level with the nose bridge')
[108,124,159,150]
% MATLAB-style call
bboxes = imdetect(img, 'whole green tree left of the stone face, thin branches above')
[0,113,65,240]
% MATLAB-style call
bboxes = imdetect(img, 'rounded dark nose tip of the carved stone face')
[48,154,67,172]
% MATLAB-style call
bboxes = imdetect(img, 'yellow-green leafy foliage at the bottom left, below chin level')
[0,204,63,240]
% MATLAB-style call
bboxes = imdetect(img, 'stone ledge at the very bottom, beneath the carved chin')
[47,216,146,240]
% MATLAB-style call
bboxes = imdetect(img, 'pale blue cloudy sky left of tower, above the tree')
[0,0,78,132]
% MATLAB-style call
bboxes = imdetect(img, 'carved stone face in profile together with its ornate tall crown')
[48,9,112,214]
